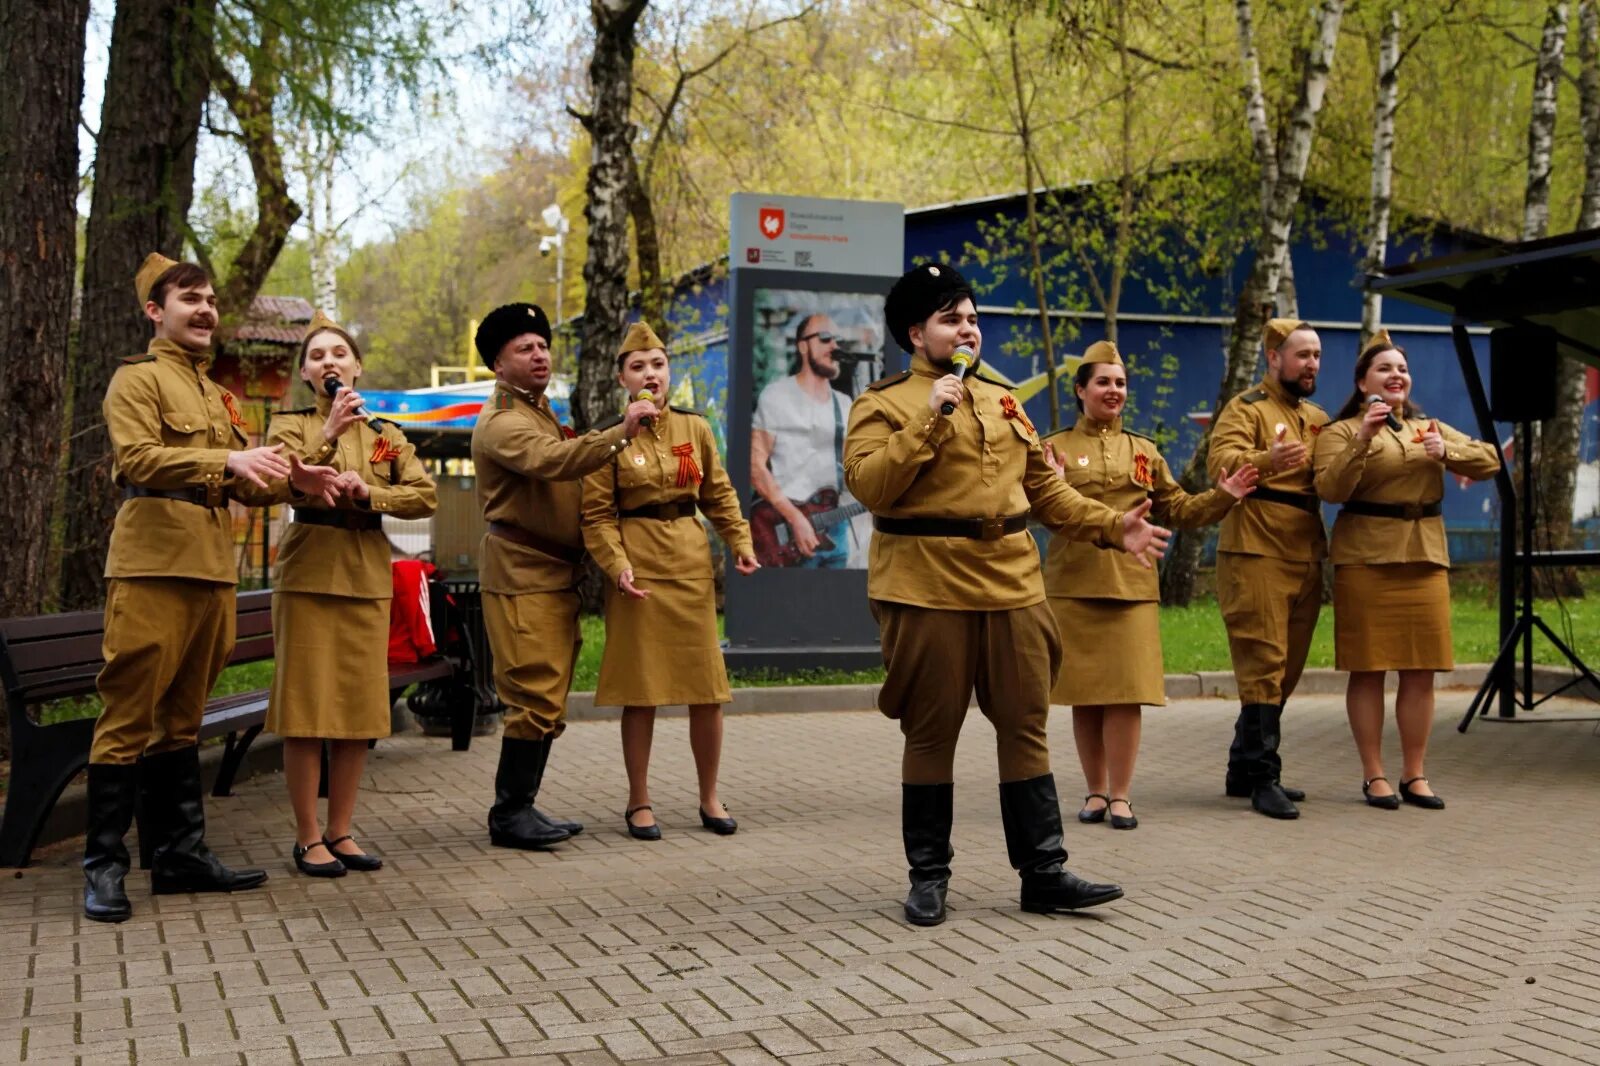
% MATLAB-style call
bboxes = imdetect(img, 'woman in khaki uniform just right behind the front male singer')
[1045,341,1258,829]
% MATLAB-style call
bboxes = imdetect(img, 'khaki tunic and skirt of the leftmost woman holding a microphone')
[267,395,437,739]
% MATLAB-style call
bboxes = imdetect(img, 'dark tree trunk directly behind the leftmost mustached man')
[61,0,216,610]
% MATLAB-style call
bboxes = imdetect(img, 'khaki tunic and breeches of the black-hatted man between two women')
[472,383,622,741]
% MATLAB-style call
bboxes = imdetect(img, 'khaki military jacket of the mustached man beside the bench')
[101,339,274,584]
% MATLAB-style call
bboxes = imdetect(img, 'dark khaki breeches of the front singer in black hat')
[872,600,1061,784]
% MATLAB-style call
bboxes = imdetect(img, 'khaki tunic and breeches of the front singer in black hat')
[845,357,1123,784]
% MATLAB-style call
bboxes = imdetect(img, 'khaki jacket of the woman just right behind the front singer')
[1045,415,1238,602]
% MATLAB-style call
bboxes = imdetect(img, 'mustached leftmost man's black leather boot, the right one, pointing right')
[139,747,267,896]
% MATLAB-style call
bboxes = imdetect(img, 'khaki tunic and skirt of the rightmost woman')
[1315,416,1501,671]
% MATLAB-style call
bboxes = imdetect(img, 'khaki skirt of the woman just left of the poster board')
[595,578,733,707]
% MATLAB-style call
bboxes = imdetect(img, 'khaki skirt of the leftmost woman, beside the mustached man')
[267,592,390,739]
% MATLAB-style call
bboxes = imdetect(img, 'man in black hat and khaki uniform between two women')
[472,304,656,848]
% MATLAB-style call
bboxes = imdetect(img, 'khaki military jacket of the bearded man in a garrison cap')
[1206,375,1328,562]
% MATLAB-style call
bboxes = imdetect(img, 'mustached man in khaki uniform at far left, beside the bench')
[83,253,338,922]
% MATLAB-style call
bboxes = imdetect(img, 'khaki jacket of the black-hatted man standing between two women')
[472,383,622,595]
